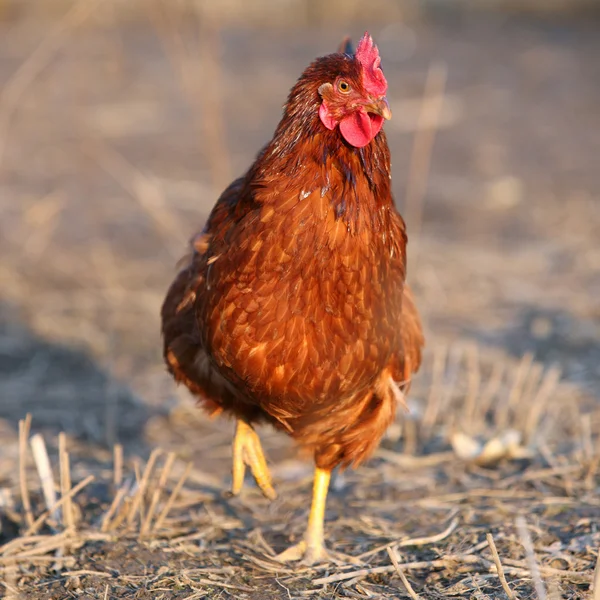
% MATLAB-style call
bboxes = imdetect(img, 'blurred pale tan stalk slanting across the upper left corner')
[0,0,100,166]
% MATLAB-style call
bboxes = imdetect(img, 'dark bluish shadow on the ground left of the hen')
[0,303,155,454]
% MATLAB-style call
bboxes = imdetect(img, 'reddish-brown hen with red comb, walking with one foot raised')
[162,34,423,563]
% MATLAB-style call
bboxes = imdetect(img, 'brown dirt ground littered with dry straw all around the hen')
[0,4,600,600]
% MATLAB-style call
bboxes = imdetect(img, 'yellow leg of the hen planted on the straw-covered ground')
[277,467,331,565]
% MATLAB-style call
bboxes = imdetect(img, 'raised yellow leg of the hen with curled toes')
[231,419,277,500]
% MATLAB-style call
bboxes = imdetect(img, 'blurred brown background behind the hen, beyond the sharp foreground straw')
[0,0,600,482]
